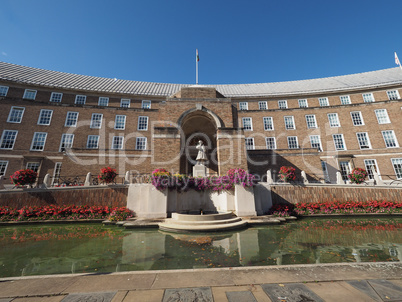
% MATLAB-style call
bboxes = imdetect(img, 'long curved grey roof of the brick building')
[0,62,402,97]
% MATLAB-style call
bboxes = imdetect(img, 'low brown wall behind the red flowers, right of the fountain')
[271,184,402,204]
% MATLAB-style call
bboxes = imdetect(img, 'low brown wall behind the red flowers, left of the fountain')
[0,185,128,208]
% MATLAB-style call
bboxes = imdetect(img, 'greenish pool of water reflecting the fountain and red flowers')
[0,218,402,277]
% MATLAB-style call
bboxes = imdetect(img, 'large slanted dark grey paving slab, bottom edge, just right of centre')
[261,283,325,302]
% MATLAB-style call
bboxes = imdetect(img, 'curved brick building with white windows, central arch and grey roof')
[0,62,402,183]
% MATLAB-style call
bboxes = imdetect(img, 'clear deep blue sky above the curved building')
[0,0,402,84]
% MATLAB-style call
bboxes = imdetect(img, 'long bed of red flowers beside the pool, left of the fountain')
[0,205,133,221]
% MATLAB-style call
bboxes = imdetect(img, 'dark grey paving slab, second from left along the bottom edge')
[162,287,214,302]
